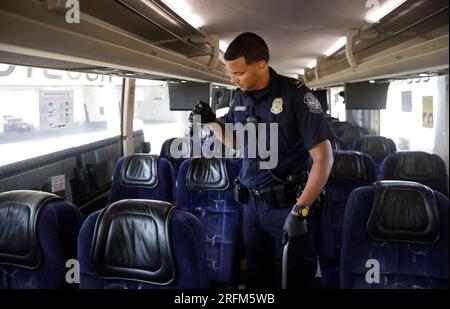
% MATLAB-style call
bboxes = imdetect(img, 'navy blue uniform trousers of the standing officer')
[242,195,317,288]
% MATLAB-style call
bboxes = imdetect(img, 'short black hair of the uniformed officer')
[224,32,269,64]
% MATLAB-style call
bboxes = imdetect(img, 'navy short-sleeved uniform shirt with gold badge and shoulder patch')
[219,68,333,189]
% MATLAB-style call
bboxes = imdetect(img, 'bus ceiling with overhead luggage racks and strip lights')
[0,0,449,88]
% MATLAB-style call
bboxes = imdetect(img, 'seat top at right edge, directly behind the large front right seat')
[380,151,448,197]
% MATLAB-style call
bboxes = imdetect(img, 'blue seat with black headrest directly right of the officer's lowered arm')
[316,151,376,288]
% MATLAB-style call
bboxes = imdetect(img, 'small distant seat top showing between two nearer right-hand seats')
[352,135,397,167]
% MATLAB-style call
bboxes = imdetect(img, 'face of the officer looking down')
[225,57,268,91]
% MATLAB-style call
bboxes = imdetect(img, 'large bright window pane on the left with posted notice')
[0,64,122,166]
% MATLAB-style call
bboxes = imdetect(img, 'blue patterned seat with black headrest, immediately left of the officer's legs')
[177,158,241,287]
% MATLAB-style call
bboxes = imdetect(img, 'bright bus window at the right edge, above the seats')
[380,76,449,170]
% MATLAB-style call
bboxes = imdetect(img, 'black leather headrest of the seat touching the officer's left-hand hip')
[186,158,230,190]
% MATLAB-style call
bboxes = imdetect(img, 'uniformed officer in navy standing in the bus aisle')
[193,33,333,287]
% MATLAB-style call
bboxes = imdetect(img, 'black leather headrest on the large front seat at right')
[367,181,440,244]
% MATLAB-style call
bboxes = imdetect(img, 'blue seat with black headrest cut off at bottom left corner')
[0,190,82,289]
